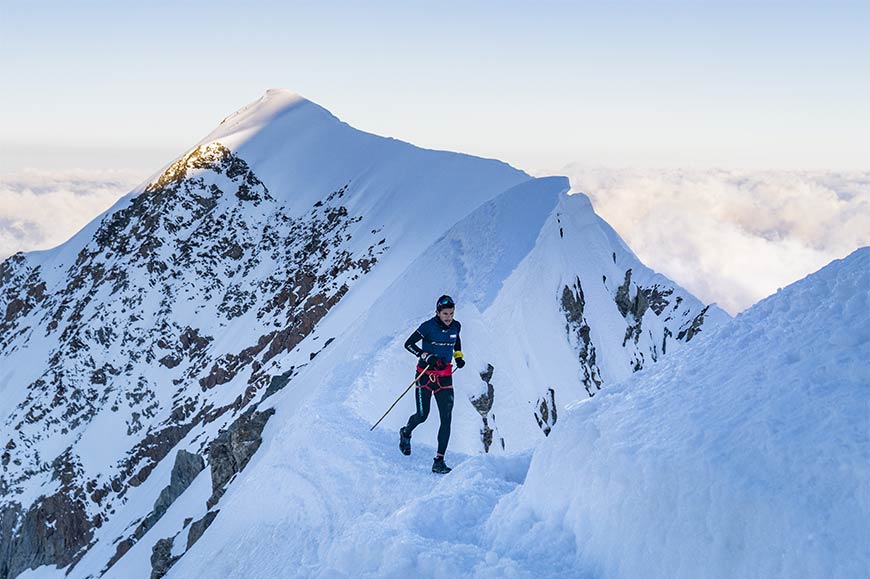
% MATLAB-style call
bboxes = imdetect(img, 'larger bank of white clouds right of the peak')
[547,165,870,314]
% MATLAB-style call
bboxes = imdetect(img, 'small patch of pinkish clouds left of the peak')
[0,170,142,260]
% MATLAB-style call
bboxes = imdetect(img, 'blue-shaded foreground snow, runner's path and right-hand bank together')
[162,262,870,578]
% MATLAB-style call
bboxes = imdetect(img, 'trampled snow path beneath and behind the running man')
[161,262,596,578]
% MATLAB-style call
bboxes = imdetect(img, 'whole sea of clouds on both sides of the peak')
[0,165,870,314]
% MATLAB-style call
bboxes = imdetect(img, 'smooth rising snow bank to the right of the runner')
[498,248,870,579]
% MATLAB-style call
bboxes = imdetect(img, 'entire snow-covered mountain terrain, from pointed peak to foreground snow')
[0,90,870,579]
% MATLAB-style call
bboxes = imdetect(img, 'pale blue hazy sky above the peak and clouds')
[0,0,870,171]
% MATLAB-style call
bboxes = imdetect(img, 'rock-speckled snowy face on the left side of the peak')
[0,142,388,579]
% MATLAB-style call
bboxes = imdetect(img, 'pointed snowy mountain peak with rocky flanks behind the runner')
[0,91,727,579]
